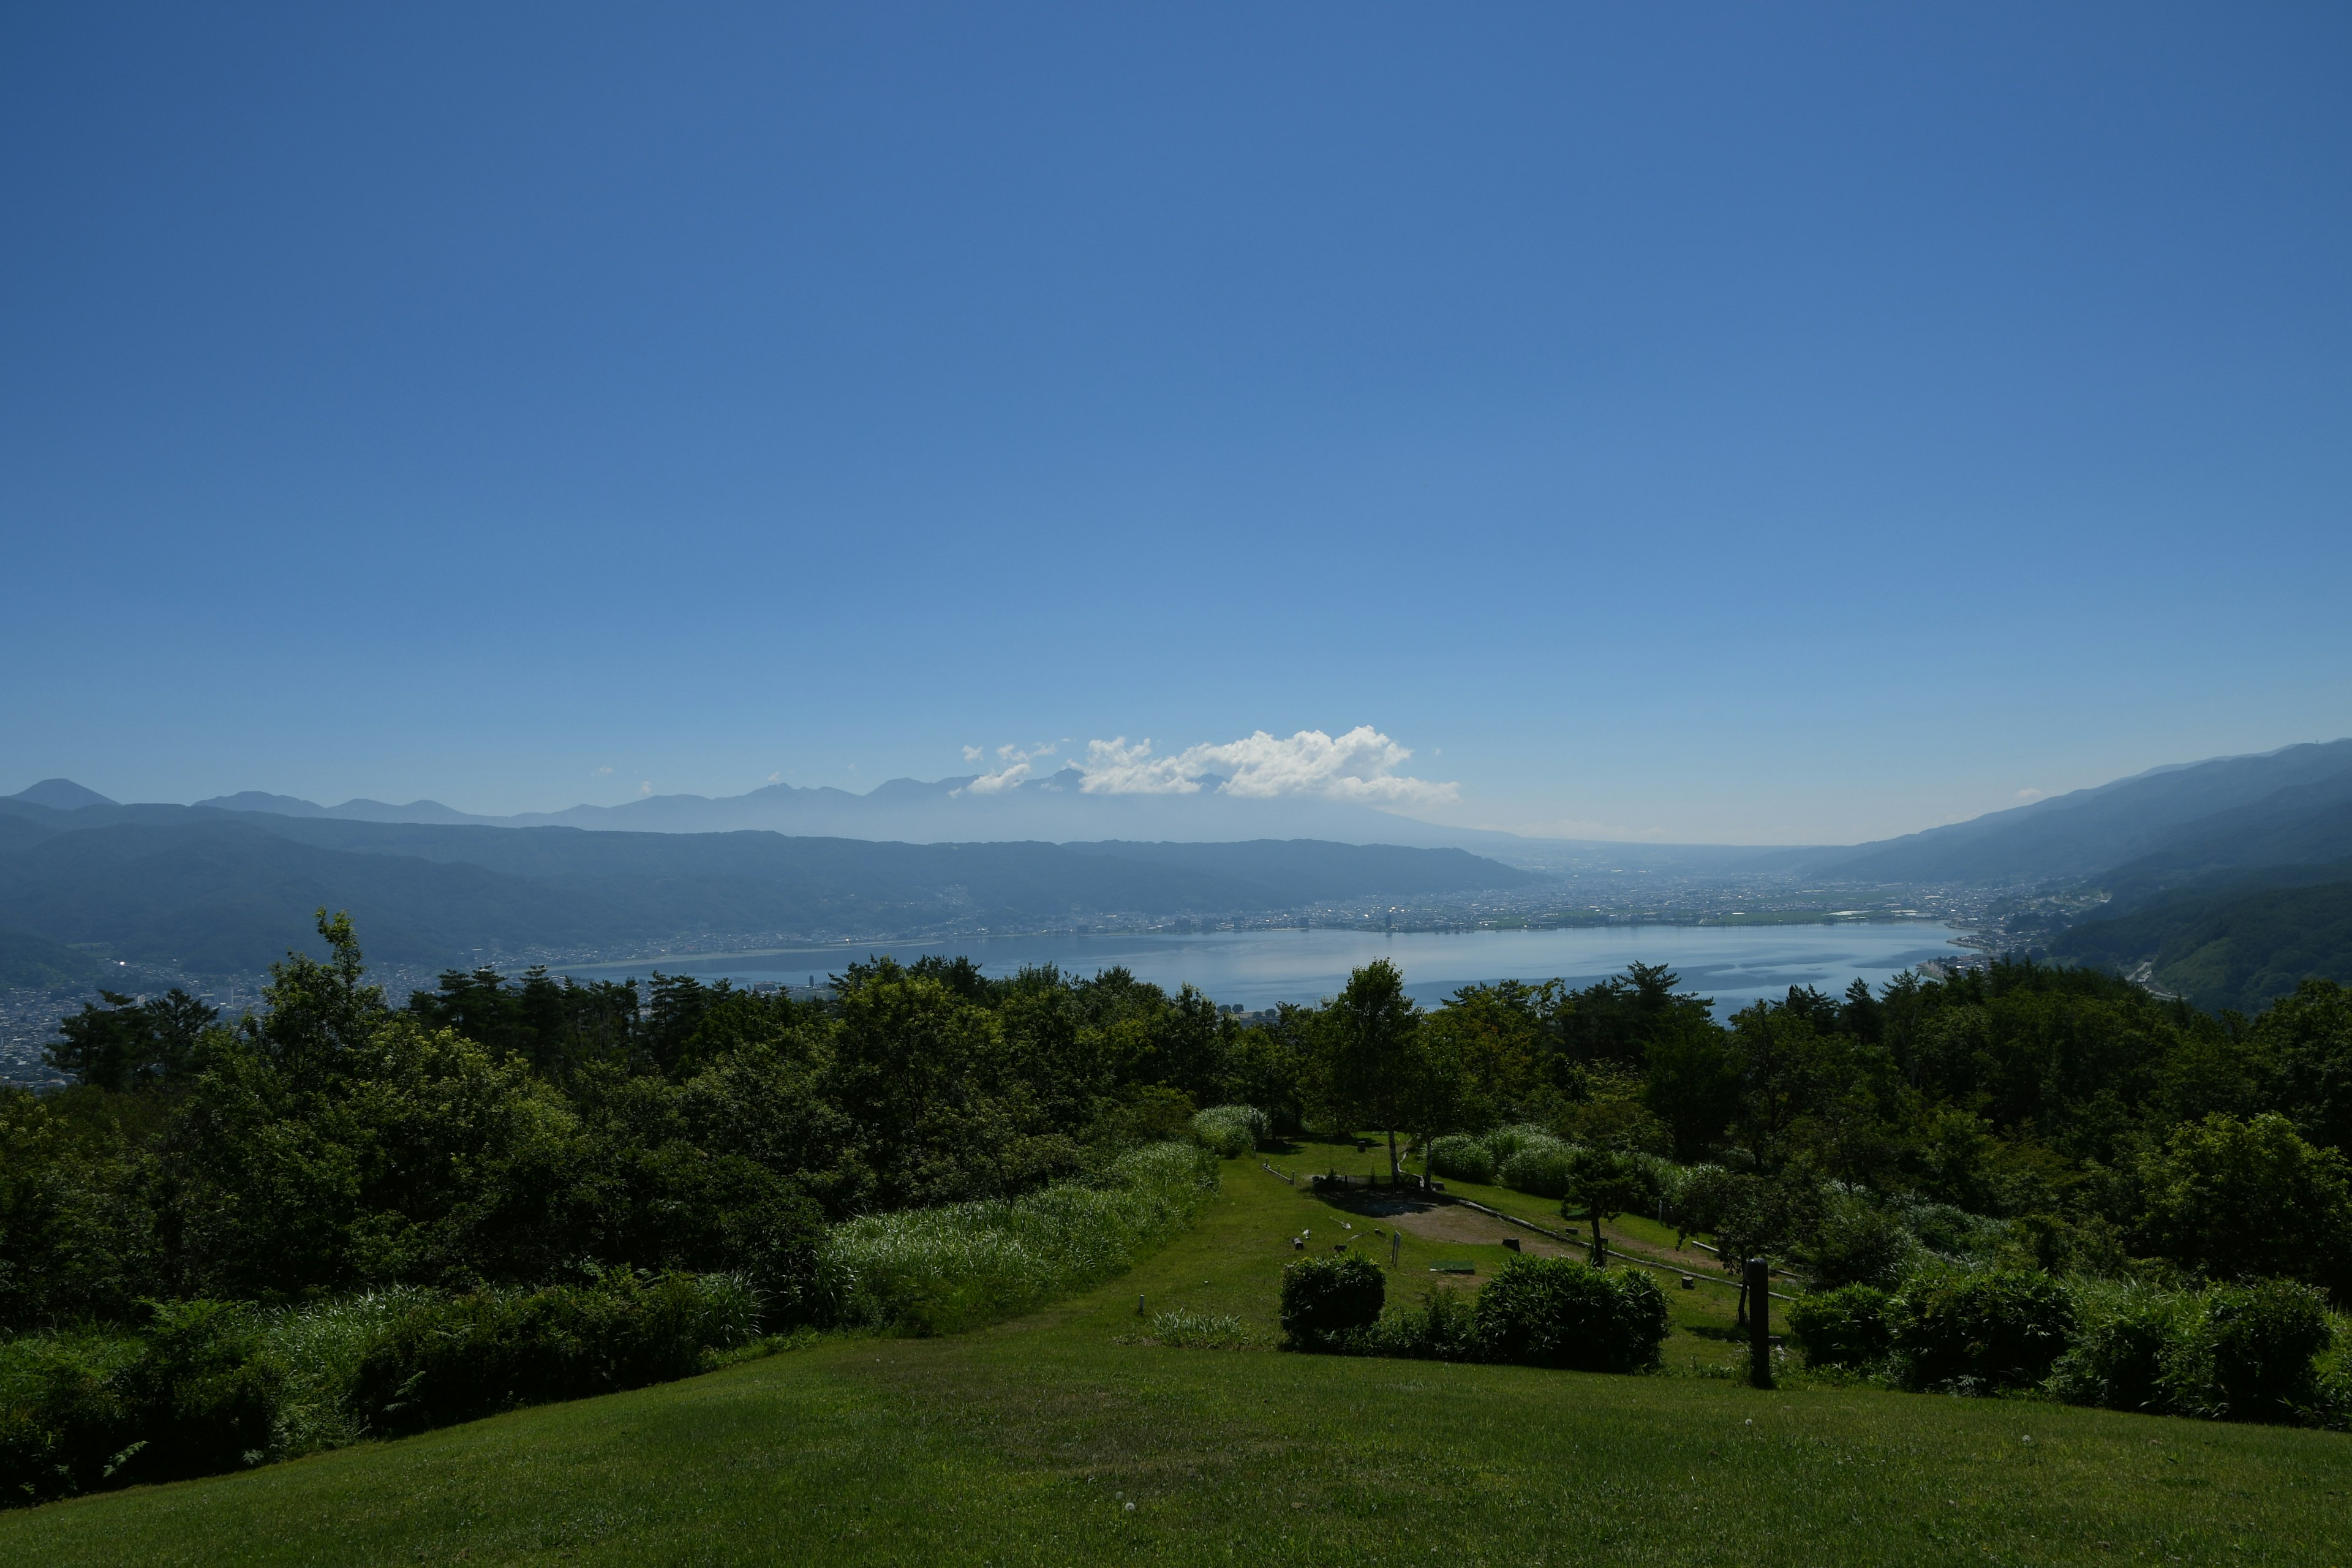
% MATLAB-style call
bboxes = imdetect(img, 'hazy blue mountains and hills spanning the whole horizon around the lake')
[13,741,2352,1006]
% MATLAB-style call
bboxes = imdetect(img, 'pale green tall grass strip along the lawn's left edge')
[818,1142,1216,1333]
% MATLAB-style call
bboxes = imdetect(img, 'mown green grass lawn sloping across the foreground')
[0,1156,2352,1568]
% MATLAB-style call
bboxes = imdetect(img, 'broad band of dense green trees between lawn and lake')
[0,914,2352,1500]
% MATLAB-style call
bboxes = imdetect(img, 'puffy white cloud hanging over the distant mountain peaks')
[1080,724,1461,806]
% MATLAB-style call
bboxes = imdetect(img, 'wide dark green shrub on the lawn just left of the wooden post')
[1472,1256,1668,1373]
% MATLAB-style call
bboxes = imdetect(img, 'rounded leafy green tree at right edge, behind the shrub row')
[2138,1112,2352,1293]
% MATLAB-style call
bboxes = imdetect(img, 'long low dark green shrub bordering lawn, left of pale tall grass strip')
[350,1274,760,1431]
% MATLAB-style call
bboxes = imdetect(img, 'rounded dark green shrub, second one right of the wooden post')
[1889,1270,2075,1392]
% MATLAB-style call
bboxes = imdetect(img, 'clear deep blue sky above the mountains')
[0,2,2352,842]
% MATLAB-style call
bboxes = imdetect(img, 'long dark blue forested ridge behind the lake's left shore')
[0,804,1536,973]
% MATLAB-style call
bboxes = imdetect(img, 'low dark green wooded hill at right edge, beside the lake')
[2051,865,2352,1013]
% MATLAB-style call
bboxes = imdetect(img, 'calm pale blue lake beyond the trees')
[562,922,1959,1018]
